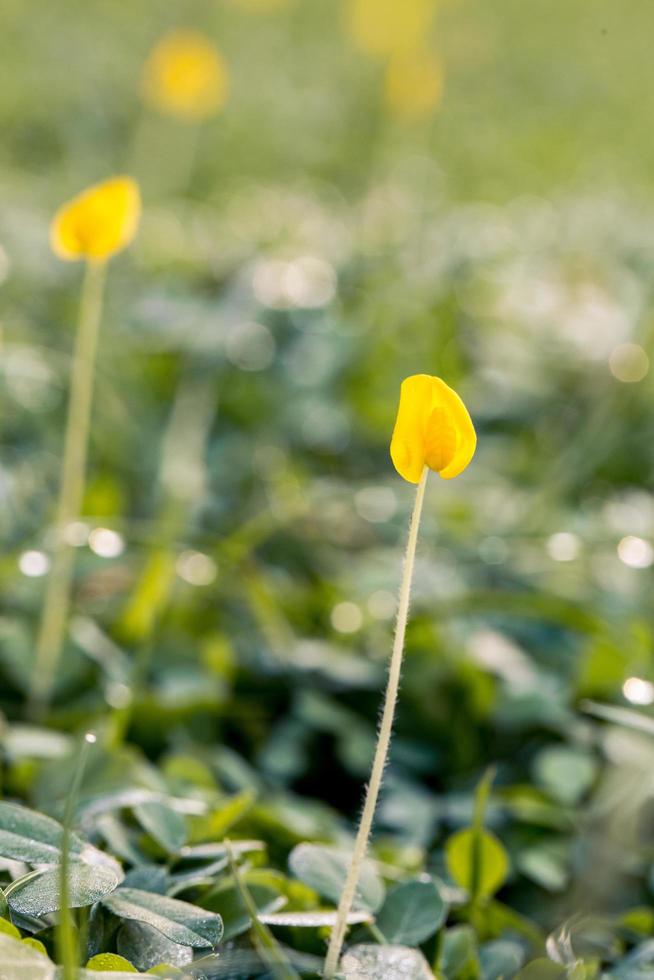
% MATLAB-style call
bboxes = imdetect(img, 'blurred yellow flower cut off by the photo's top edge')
[346,0,435,56]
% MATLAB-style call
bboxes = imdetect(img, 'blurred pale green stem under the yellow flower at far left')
[30,262,105,710]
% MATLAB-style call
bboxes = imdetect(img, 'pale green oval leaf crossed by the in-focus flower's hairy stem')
[288,844,385,912]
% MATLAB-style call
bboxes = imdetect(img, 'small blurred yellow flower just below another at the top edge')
[385,49,443,119]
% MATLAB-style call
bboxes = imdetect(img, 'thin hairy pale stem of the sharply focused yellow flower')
[323,467,429,980]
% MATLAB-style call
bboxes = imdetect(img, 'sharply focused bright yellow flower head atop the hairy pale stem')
[391,374,477,483]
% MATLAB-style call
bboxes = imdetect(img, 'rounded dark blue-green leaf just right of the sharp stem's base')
[376,881,447,946]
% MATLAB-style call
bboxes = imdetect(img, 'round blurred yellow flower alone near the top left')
[142,31,229,119]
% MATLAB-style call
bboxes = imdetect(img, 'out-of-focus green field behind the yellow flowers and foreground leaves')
[0,0,654,964]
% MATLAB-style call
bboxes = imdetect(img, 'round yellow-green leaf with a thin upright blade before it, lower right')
[445,828,509,898]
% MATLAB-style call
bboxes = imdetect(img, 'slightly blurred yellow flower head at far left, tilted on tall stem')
[50,177,141,262]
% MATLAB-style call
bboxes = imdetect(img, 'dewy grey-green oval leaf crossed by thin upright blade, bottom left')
[7,862,120,917]
